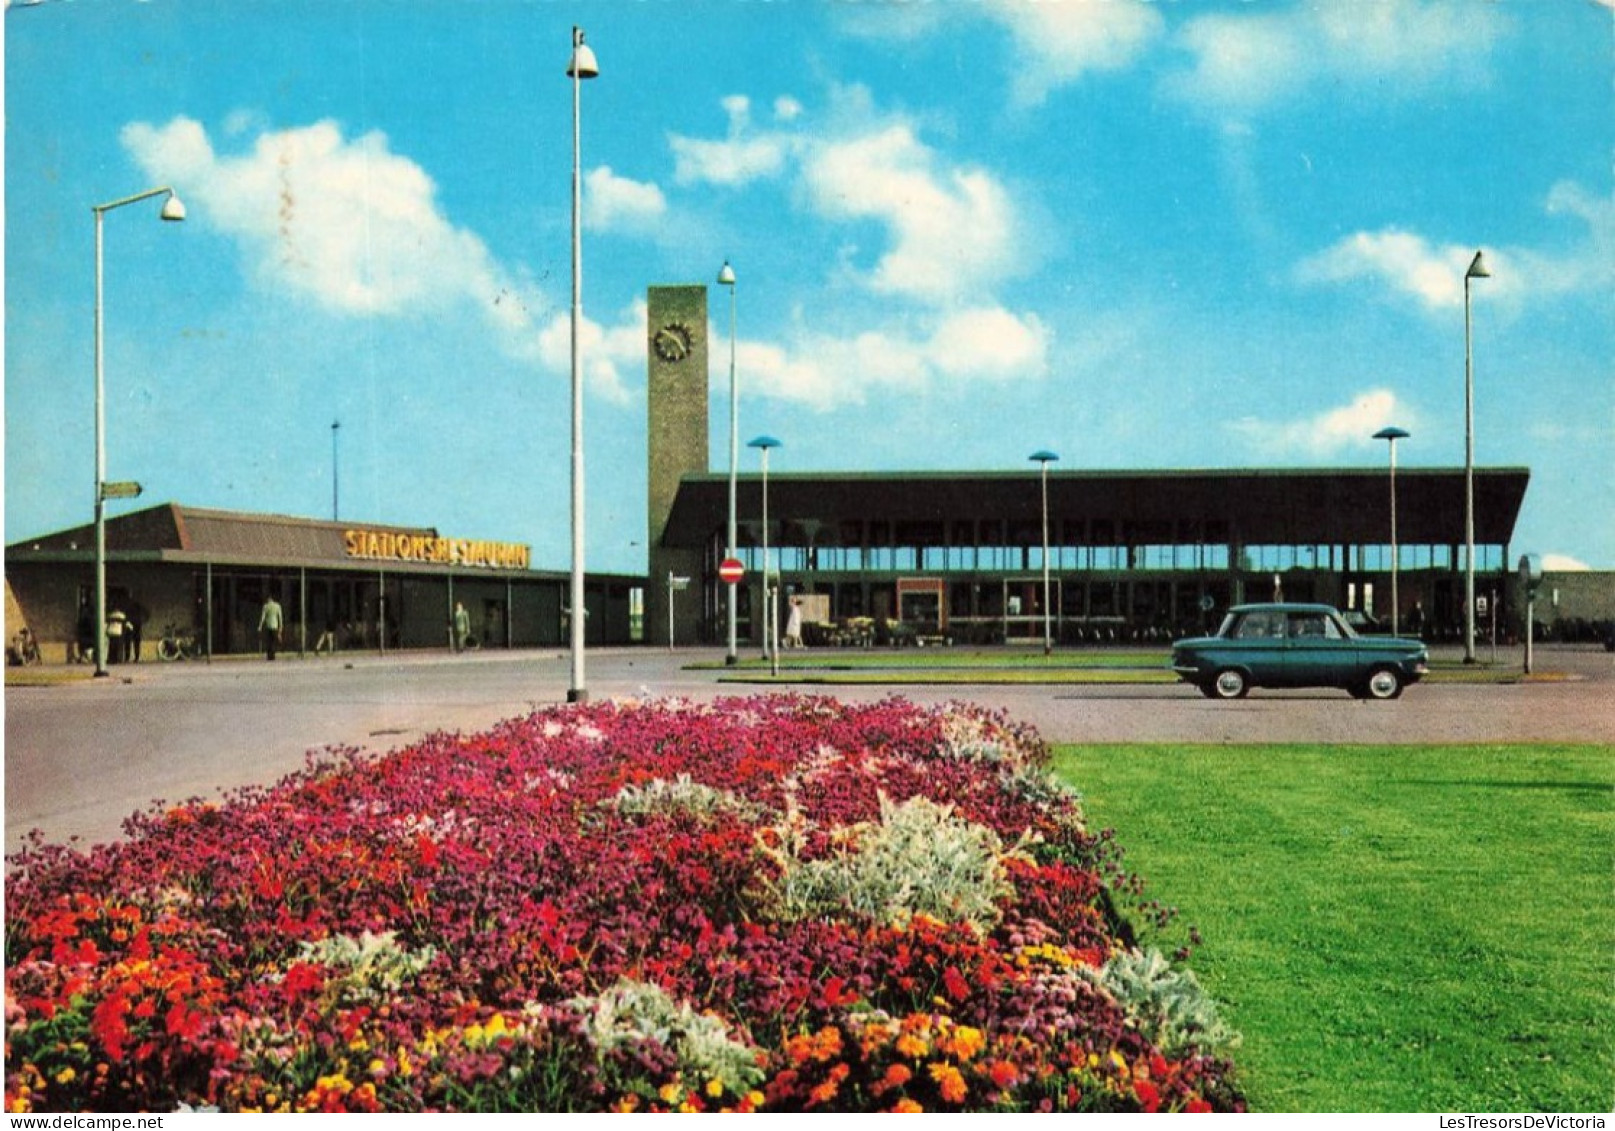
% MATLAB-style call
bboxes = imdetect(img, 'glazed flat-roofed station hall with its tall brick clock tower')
[646,284,1529,645]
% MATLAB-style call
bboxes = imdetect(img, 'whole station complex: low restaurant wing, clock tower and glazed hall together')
[6,277,1550,659]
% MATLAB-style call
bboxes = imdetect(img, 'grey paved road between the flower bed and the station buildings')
[5,648,1615,853]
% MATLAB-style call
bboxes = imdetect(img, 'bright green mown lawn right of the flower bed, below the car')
[1056,745,1615,1113]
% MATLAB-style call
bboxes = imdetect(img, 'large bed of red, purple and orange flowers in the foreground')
[6,696,1242,1112]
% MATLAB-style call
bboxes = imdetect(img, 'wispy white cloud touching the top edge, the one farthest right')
[1168,0,1507,110]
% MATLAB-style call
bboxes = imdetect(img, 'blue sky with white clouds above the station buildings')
[5,0,1615,570]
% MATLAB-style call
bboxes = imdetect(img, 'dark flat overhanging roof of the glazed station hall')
[662,467,1531,548]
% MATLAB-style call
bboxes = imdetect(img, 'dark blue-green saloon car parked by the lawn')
[1172,604,1429,700]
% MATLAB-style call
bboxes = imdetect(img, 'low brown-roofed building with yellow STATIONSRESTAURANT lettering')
[5,502,643,661]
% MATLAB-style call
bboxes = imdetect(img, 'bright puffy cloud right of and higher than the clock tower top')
[803,123,1017,302]
